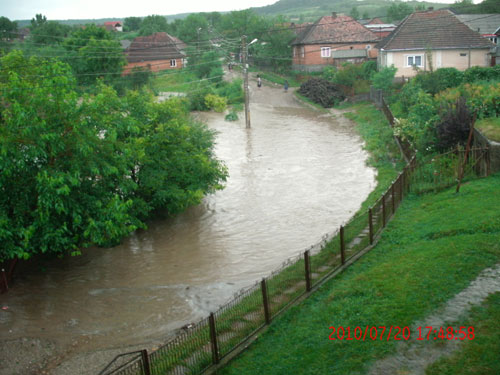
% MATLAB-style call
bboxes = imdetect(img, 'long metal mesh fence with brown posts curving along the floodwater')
[100,101,489,375]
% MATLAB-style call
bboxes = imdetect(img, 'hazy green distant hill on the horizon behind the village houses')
[17,0,453,27]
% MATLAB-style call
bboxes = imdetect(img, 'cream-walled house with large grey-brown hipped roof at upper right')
[376,10,495,77]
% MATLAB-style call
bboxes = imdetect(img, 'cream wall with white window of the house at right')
[379,49,491,77]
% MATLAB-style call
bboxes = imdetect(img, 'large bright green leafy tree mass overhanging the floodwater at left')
[0,51,226,261]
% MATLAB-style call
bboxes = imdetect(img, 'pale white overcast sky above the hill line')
[0,0,460,20]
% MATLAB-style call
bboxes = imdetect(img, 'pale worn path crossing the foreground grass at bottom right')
[370,264,500,375]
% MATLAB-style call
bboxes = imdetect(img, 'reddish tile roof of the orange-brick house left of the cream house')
[292,15,378,45]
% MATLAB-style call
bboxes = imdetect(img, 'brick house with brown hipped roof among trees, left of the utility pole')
[123,32,186,74]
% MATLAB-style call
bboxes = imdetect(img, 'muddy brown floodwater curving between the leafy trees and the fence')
[0,81,375,374]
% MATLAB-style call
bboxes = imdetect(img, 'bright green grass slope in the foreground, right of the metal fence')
[220,174,500,375]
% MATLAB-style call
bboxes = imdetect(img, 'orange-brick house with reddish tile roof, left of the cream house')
[292,13,378,72]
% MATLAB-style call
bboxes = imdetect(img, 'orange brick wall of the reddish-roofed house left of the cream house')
[292,43,378,71]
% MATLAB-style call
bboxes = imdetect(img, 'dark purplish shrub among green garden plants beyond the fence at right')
[437,96,472,151]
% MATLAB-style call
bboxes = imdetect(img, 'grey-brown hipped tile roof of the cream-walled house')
[376,9,495,50]
